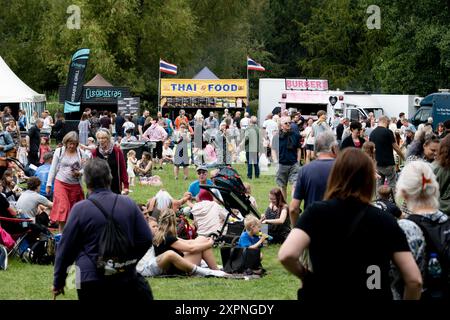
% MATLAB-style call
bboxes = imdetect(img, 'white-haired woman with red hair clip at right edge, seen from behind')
[393,161,449,300]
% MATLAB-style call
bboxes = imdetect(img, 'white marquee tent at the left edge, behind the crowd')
[0,57,46,127]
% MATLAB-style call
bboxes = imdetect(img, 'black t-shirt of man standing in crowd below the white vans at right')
[369,127,395,167]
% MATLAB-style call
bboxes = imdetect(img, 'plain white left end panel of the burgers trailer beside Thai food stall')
[258,78,286,126]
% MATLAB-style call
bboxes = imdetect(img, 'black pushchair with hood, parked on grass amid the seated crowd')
[200,166,259,245]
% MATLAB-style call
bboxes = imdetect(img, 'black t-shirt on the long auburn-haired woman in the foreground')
[295,199,410,301]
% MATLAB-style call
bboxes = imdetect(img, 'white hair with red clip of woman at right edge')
[396,161,440,210]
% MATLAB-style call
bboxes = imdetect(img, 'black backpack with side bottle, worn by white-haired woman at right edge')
[408,214,450,299]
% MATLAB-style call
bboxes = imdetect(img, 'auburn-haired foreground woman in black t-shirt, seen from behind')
[278,148,422,301]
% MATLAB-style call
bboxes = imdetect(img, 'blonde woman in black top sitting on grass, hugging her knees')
[153,209,226,276]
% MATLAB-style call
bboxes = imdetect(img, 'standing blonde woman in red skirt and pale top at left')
[46,131,85,232]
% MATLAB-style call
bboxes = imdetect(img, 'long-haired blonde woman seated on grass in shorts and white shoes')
[149,209,227,277]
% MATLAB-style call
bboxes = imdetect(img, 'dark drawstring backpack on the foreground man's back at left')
[89,195,137,276]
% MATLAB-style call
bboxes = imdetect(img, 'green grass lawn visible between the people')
[0,165,299,300]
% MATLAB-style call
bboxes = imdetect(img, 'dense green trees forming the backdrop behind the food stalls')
[0,0,450,101]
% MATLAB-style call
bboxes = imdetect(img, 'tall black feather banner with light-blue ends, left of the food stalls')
[64,49,89,113]
